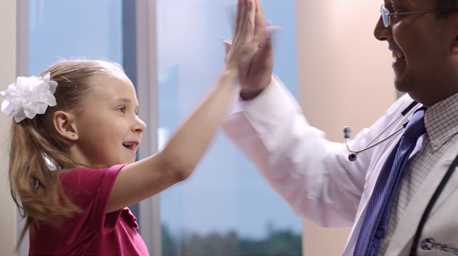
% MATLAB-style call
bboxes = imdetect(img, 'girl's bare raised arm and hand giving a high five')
[107,0,259,213]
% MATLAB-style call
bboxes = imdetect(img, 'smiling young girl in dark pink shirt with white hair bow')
[2,0,257,255]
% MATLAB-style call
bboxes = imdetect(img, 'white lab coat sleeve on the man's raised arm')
[222,78,405,227]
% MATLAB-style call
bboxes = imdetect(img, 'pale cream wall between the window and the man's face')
[296,0,396,256]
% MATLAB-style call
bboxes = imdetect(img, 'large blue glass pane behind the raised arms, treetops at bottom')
[157,0,302,256]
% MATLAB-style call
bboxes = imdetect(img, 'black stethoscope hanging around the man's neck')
[344,101,458,256]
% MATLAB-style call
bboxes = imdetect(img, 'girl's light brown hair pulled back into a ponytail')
[9,60,124,245]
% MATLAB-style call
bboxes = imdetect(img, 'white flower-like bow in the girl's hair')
[0,73,57,123]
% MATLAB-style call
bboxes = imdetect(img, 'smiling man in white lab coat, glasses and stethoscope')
[223,0,458,255]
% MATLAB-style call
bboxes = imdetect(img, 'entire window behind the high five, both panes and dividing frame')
[18,0,302,256]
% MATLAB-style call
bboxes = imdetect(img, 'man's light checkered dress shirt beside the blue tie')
[378,93,458,256]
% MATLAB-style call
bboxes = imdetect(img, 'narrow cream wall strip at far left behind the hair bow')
[0,0,16,256]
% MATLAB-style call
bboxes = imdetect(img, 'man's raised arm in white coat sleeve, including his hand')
[222,0,364,226]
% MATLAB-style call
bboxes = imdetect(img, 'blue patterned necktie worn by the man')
[353,108,426,256]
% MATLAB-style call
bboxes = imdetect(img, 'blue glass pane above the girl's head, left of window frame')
[29,0,123,75]
